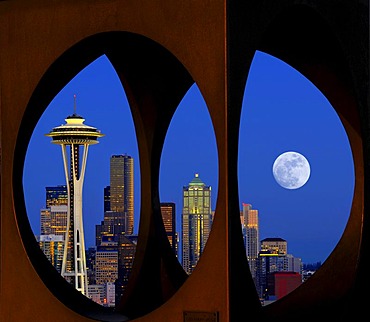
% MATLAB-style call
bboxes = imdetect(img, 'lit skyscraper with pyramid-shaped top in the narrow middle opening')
[182,173,212,274]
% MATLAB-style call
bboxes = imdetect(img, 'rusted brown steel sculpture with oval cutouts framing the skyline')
[0,0,370,322]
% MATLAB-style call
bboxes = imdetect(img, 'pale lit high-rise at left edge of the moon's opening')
[241,203,260,280]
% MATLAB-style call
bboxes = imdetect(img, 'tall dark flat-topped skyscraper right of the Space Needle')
[110,155,134,235]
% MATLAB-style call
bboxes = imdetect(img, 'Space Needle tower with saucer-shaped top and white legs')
[45,95,104,296]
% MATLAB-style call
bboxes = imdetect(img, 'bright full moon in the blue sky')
[272,151,311,189]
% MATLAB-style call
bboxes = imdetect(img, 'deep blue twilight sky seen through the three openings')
[23,52,354,263]
